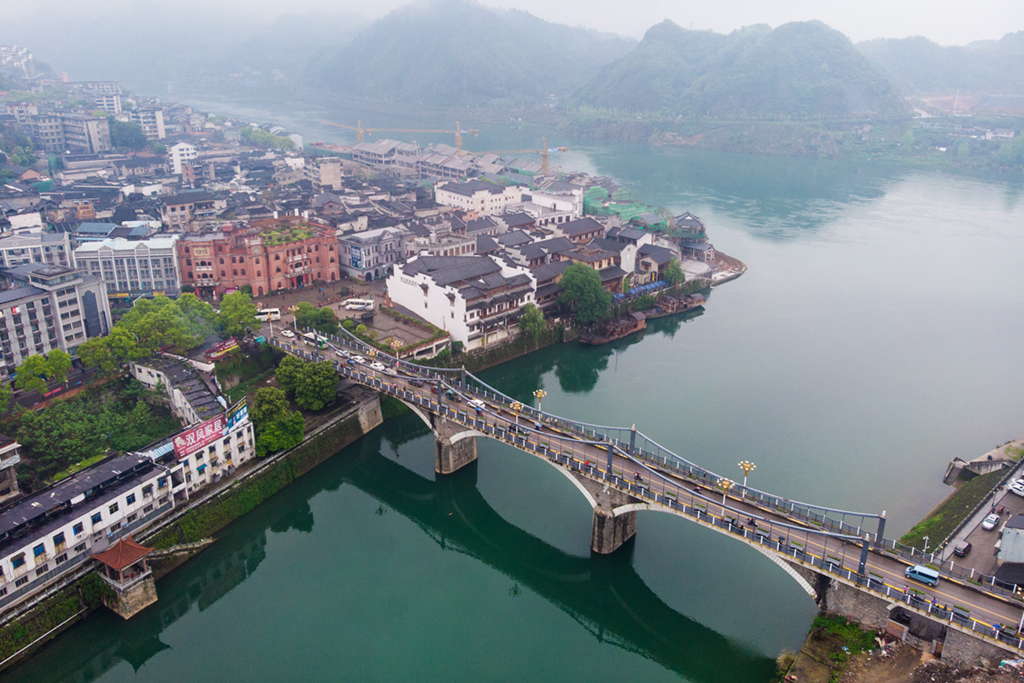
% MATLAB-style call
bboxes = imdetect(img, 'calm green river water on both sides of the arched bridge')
[4,101,1024,683]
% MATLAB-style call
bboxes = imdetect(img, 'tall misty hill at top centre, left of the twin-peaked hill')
[306,0,636,106]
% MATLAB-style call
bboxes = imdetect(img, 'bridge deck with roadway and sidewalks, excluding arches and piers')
[270,331,1024,654]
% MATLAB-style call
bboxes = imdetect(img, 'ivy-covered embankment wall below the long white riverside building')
[0,386,383,671]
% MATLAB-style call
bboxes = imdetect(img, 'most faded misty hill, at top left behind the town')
[0,1,368,91]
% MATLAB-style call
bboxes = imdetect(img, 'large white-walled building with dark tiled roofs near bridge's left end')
[387,256,537,350]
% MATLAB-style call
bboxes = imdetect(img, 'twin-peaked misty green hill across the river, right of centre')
[575,20,905,119]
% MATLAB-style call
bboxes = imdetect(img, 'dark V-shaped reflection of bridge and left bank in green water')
[10,418,773,683]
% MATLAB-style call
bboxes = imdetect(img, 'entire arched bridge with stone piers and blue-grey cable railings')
[269,330,1024,664]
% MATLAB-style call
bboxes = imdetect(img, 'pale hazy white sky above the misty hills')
[0,0,1024,45]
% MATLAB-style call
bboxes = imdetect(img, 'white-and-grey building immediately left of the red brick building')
[74,234,181,298]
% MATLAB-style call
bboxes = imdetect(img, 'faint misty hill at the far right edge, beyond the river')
[857,31,1024,95]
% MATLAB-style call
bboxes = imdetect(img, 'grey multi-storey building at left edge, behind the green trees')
[0,263,111,381]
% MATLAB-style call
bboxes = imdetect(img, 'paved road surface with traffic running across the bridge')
[278,334,1024,643]
